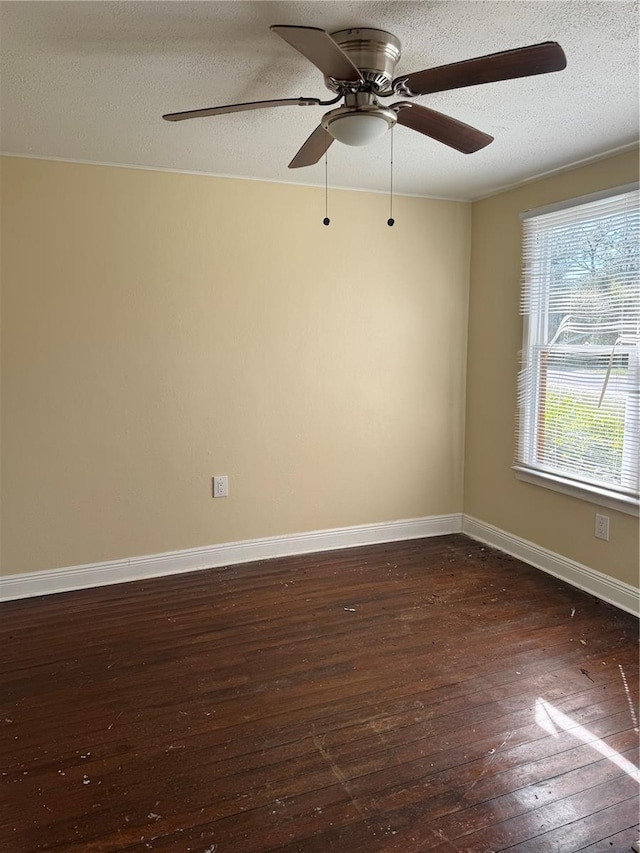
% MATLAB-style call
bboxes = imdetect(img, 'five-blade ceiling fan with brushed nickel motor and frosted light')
[163,24,567,169]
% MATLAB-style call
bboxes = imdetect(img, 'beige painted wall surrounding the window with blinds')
[464,152,639,585]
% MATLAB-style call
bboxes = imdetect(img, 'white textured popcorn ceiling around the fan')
[0,0,639,199]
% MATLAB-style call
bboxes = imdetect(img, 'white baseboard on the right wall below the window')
[462,515,640,616]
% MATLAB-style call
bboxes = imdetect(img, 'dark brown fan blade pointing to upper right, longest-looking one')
[393,41,567,95]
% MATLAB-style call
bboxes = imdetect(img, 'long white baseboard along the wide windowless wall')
[0,513,462,601]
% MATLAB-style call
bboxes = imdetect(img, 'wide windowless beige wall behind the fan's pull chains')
[2,158,470,574]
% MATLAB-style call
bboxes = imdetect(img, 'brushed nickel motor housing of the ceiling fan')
[325,29,401,95]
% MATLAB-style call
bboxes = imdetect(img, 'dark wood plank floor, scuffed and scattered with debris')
[0,536,640,853]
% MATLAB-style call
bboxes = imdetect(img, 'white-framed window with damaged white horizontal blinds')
[514,186,640,514]
